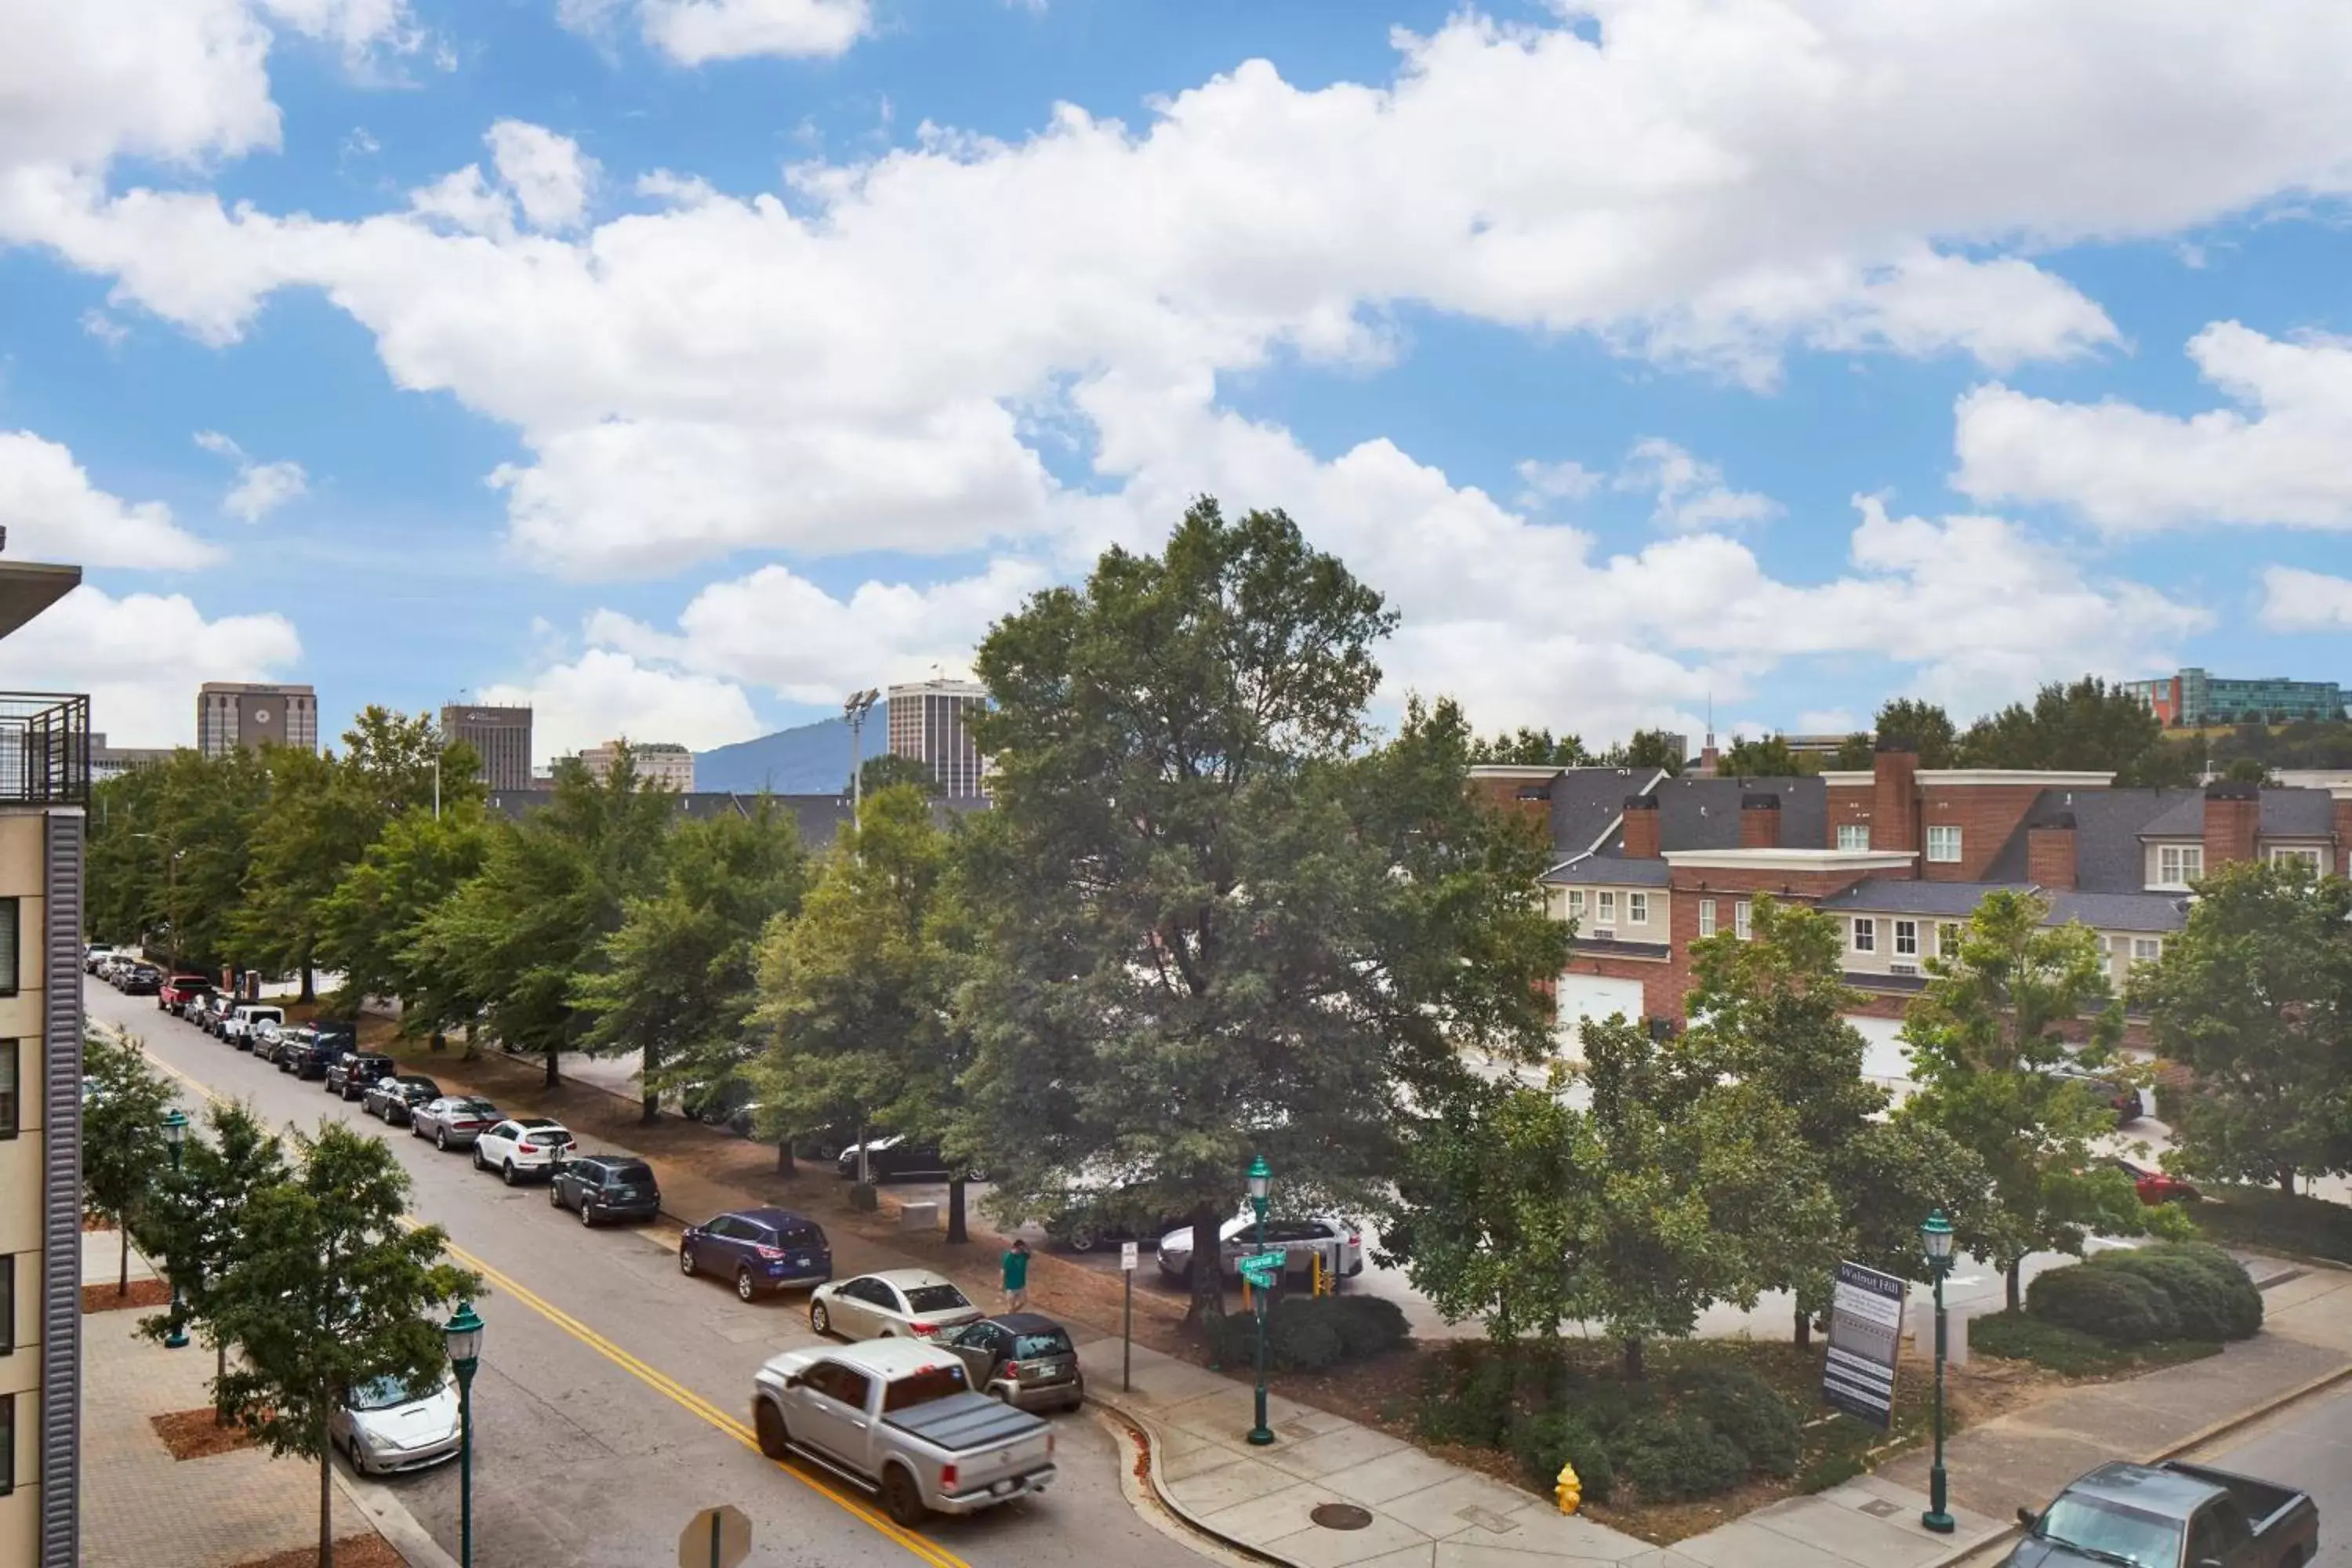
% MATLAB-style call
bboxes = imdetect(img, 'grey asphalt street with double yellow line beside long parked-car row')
[85,980,1202,1568]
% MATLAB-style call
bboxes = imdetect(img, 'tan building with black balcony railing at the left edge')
[0,562,89,1568]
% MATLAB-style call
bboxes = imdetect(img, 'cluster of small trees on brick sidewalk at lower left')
[85,1029,482,1566]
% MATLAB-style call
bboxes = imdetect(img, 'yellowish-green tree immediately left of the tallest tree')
[750,785,971,1239]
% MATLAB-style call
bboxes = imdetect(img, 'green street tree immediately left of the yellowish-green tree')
[572,799,809,1123]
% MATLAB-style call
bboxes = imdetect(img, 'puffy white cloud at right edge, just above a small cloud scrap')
[1955,322,2352,534]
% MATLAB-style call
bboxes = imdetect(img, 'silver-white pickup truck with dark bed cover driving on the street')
[753,1340,1054,1528]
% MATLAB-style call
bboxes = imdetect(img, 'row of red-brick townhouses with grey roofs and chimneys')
[1475,741,2352,1079]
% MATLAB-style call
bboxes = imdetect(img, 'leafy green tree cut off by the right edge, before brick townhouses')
[2131,860,2352,1192]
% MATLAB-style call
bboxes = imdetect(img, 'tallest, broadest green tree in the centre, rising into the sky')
[946,501,1566,1319]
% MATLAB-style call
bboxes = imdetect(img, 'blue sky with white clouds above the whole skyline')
[0,0,2352,753]
